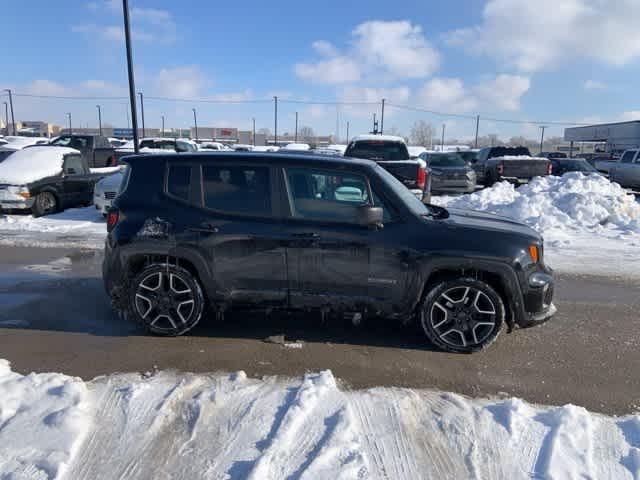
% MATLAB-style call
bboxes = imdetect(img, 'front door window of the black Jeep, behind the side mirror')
[287,168,371,223]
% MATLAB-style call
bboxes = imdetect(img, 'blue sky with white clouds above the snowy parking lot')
[0,0,640,138]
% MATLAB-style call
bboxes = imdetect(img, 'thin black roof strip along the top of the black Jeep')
[122,151,376,169]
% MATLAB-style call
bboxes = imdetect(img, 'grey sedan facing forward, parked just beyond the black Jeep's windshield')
[420,152,476,194]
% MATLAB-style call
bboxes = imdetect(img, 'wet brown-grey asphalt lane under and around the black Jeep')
[0,246,640,414]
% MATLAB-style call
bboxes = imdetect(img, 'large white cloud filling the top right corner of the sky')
[445,0,640,72]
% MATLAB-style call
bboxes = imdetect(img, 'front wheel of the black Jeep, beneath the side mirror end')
[420,278,505,353]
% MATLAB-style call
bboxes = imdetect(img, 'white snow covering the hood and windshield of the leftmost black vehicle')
[0,147,80,185]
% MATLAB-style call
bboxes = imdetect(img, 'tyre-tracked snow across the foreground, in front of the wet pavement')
[0,360,640,480]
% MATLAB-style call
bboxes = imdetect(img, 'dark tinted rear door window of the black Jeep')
[202,165,271,216]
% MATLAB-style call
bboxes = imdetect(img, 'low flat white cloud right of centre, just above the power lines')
[416,74,530,113]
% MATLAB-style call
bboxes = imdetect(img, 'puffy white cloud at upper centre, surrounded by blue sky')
[294,21,440,85]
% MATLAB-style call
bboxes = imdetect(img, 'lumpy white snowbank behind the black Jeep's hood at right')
[432,172,640,277]
